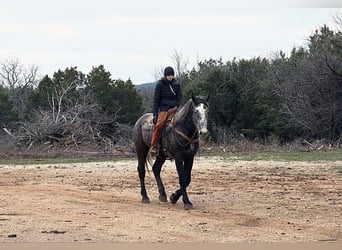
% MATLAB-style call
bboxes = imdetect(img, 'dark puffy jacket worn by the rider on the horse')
[153,78,183,117]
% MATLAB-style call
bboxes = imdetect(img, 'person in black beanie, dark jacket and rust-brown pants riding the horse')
[150,66,183,155]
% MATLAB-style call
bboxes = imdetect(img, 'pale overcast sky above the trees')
[0,0,342,84]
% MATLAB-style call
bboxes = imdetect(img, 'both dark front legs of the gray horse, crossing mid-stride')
[170,154,193,209]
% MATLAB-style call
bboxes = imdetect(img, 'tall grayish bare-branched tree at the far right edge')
[275,26,342,143]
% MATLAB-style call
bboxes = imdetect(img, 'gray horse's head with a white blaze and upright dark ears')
[191,95,209,134]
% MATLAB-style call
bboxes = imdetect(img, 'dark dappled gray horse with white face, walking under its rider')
[134,95,209,209]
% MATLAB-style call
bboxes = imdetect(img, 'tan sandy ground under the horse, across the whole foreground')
[0,156,342,242]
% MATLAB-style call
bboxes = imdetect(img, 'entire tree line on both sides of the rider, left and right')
[0,25,342,151]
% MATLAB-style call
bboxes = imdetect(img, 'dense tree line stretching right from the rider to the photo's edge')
[182,26,342,143]
